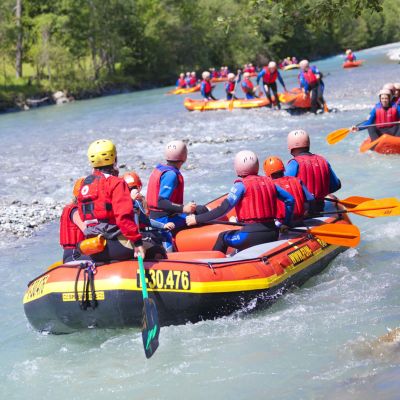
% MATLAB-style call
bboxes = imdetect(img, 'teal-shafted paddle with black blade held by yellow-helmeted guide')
[138,255,160,358]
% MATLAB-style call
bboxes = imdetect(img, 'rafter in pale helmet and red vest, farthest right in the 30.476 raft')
[285,129,342,212]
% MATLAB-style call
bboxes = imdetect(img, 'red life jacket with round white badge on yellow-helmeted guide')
[77,171,115,225]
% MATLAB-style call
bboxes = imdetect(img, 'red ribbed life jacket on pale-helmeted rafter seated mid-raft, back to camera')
[235,175,278,223]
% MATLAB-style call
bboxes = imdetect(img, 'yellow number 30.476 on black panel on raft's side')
[136,269,190,290]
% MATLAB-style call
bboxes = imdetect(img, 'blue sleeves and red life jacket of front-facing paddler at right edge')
[358,103,400,141]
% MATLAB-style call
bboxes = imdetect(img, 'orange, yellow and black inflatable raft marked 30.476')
[23,214,350,334]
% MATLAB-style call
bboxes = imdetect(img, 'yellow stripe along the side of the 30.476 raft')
[23,246,338,304]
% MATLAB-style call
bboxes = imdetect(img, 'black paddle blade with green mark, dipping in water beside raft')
[142,298,160,358]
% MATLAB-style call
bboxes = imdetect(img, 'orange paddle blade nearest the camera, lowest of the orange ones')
[308,224,360,247]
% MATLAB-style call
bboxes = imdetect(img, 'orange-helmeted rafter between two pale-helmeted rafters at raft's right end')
[263,157,315,224]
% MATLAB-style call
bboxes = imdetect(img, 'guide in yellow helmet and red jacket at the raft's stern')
[78,139,145,262]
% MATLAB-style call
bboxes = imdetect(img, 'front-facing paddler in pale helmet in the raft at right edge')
[352,89,400,141]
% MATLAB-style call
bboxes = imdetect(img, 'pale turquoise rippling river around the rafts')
[0,43,400,400]
